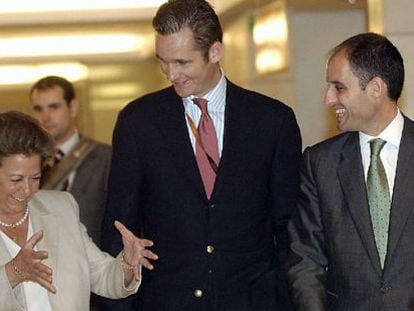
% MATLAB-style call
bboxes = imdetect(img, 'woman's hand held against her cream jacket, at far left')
[8,231,56,293]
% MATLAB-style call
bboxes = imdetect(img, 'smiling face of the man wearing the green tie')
[325,52,379,135]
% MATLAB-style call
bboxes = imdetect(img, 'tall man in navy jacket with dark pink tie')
[103,0,301,311]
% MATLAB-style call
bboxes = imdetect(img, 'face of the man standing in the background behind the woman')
[31,86,77,144]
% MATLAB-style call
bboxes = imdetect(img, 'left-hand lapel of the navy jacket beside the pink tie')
[157,87,206,196]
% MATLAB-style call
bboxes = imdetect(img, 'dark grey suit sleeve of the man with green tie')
[288,150,328,311]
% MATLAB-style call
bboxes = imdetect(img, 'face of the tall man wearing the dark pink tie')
[155,28,221,97]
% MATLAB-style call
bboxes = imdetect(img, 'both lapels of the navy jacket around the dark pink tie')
[158,80,261,197]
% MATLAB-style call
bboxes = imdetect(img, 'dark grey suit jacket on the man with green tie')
[289,118,414,311]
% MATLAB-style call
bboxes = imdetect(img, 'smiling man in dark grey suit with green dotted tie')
[288,33,414,311]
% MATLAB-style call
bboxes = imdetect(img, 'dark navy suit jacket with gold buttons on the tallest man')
[103,82,301,311]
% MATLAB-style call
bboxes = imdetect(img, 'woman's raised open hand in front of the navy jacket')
[115,221,158,276]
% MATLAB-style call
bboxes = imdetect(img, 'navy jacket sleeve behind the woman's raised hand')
[101,111,142,310]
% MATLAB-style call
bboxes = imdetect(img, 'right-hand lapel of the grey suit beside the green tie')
[386,118,414,268]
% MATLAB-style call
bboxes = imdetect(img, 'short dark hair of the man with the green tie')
[331,33,404,101]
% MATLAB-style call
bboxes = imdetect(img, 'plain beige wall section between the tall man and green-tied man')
[288,10,367,147]
